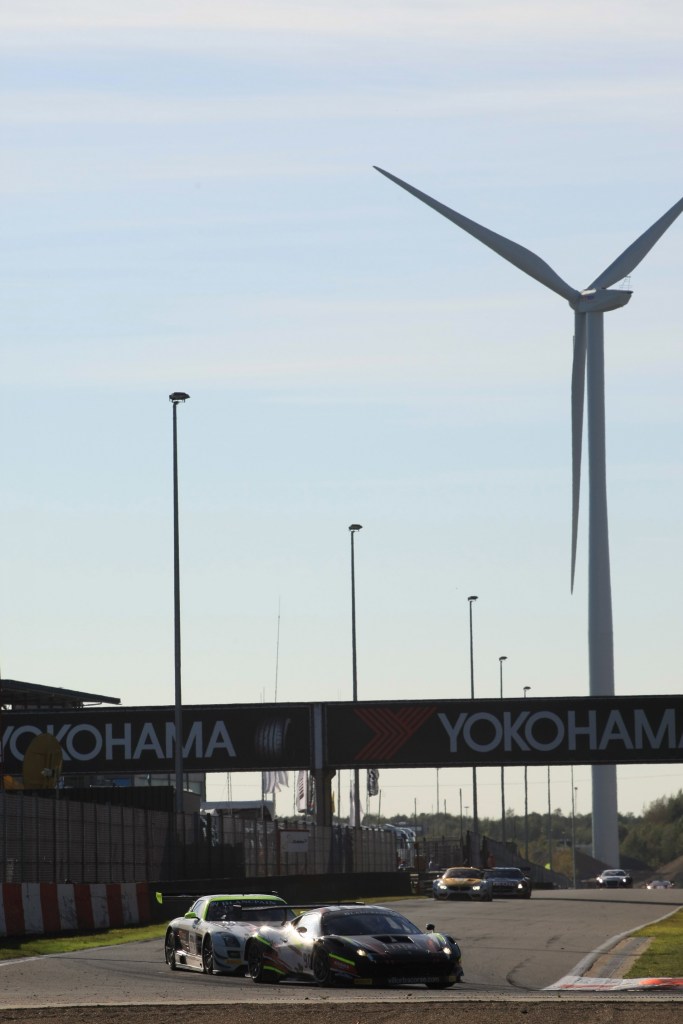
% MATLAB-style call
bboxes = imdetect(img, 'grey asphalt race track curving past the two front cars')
[0,890,682,1024]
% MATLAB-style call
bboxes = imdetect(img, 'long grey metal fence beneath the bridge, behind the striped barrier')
[0,791,396,883]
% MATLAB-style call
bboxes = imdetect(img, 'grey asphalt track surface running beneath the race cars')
[0,890,683,1024]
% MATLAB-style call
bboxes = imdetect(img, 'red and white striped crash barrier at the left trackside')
[0,882,151,937]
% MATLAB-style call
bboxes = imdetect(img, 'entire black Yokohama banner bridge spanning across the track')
[0,695,683,775]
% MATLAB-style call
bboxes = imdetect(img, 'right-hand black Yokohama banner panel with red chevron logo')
[326,696,683,768]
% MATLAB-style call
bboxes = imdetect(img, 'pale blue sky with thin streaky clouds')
[0,0,683,817]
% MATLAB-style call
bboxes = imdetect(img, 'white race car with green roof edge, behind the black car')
[164,893,294,975]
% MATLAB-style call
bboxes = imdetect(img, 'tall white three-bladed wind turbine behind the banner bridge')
[375,167,683,864]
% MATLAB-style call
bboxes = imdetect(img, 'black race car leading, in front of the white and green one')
[247,904,463,988]
